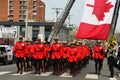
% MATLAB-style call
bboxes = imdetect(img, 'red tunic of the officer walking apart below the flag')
[93,45,105,59]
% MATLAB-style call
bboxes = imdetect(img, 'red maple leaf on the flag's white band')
[87,0,113,21]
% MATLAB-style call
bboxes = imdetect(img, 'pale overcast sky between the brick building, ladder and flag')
[42,0,120,32]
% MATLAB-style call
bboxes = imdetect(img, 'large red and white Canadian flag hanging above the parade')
[76,0,116,40]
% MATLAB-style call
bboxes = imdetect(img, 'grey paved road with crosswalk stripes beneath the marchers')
[0,59,120,80]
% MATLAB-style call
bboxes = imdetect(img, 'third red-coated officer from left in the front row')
[49,37,63,75]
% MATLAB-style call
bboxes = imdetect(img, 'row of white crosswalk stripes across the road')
[0,71,117,80]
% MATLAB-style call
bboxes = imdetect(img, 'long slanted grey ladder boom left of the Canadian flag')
[48,0,76,43]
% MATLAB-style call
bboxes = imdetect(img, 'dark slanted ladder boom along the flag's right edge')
[109,0,120,38]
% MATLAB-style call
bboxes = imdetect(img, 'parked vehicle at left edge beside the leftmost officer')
[0,45,14,64]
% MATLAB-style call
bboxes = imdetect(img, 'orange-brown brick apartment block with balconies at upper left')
[0,0,45,22]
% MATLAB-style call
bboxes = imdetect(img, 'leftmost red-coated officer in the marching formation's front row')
[13,35,26,74]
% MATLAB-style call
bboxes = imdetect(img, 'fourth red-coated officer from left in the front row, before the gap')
[68,42,79,77]
